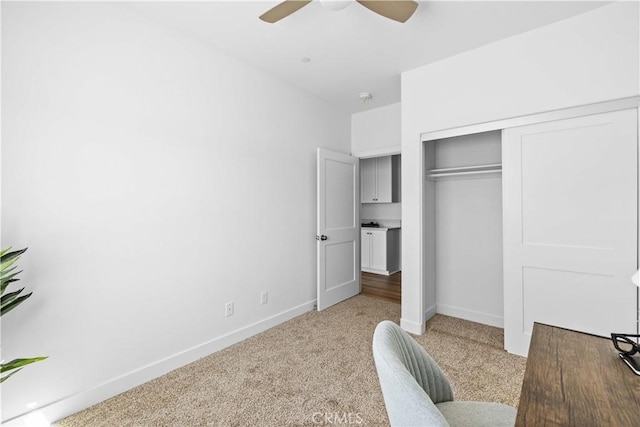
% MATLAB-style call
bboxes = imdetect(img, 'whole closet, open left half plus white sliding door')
[421,99,640,356]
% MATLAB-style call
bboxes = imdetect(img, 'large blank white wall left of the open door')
[2,2,350,421]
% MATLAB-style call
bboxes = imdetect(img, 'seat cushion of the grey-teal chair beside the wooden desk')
[436,400,517,427]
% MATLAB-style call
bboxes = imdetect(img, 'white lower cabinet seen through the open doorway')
[360,228,400,275]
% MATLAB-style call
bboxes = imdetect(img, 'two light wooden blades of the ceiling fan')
[260,0,418,24]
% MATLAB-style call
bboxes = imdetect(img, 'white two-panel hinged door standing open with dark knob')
[316,148,360,310]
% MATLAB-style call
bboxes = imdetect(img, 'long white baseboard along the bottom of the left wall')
[2,300,316,427]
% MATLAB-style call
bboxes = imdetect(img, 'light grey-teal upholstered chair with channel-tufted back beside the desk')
[373,320,516,427]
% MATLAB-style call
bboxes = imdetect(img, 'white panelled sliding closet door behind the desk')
[502,110,638,356]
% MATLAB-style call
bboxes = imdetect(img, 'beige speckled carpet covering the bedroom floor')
[57,295,526,427]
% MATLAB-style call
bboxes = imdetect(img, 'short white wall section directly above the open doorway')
[351,102,401,157]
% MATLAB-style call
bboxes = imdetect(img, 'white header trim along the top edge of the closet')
[420,96,640,142]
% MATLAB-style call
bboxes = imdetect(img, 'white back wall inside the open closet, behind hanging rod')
[436,131,504,327]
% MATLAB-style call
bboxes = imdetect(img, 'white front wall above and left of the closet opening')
[401,2,640,333]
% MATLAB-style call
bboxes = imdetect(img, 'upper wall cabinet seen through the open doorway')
[360,155,400,203]
